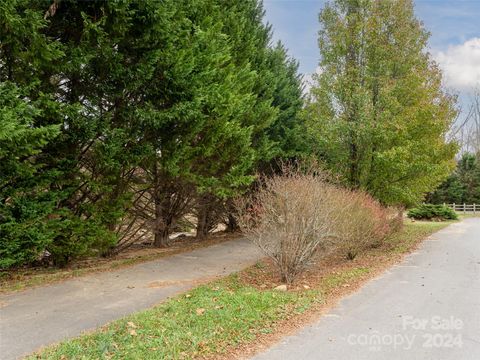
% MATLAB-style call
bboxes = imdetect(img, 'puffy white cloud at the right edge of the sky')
[434,37,480,91]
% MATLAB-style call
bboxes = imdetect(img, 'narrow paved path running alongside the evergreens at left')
[0,239,262,360]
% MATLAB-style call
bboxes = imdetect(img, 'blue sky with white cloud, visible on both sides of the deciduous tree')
[264,0,480,107]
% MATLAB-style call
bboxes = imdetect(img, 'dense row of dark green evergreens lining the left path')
[0,0,302,267]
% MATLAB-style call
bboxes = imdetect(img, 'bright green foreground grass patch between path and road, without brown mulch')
[27,275,319,359]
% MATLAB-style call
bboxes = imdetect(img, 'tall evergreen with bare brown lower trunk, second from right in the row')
[131,0,255,246]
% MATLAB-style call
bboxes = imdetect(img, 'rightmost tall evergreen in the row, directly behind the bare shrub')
[193,0,303,238]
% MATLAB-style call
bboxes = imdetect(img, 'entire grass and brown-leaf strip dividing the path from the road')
[30,222,451,359]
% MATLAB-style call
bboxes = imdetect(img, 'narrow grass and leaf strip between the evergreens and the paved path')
[0,233,239,294]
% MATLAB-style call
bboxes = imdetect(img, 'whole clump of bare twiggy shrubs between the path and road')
[237,168,401,283]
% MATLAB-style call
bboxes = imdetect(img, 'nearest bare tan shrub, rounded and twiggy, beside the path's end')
[237,169,341,283]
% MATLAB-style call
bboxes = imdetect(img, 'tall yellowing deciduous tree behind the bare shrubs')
[305,0,457,205]
